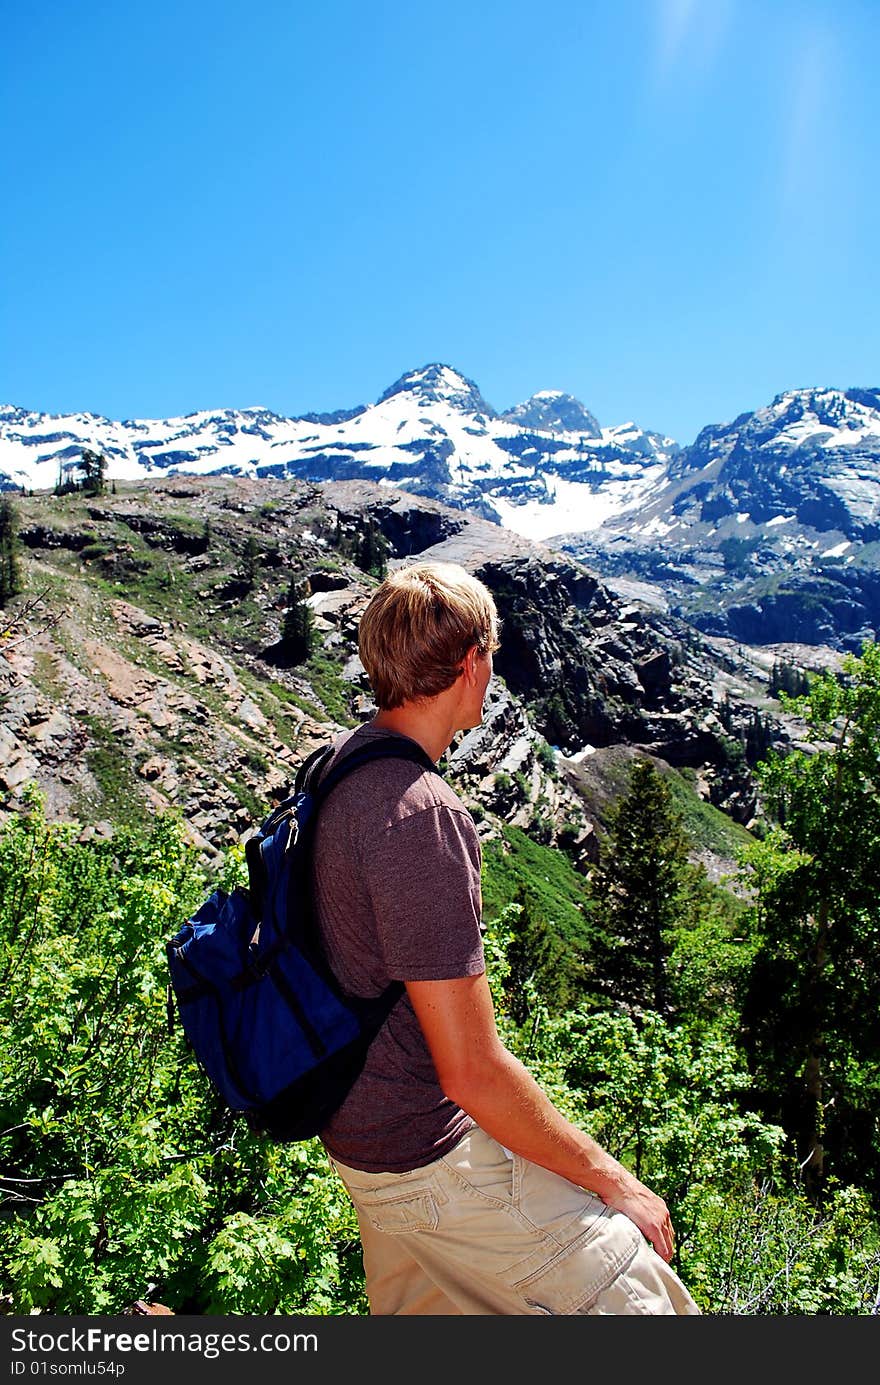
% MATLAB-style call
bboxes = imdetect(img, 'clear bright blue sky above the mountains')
[0,0,880,443]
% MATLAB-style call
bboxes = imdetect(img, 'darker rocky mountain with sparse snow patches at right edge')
[554,389,880,650]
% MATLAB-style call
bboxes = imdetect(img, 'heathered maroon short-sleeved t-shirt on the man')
[315,723,485,1173]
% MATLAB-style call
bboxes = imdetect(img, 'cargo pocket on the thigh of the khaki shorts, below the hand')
[511,1208,642,1316]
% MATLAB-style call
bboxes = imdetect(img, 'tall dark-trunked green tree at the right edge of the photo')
[743,643,880,1198]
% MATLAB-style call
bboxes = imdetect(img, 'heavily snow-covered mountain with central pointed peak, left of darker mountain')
[0,364,679,539]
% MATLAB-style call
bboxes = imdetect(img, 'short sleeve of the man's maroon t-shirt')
[367,803,485,981]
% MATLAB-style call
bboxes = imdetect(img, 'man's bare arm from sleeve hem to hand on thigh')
[406,972,672,1260]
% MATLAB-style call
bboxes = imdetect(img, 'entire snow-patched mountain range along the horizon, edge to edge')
[6,361,880,652]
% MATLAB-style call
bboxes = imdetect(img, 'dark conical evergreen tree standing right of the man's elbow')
[589,758,693,1014]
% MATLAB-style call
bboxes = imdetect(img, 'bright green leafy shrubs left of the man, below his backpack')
[0,795,366,1314]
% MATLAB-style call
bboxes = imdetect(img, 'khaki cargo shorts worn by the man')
[331,1127,700,1316]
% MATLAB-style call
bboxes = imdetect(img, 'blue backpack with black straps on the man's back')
[166,737,439,1140]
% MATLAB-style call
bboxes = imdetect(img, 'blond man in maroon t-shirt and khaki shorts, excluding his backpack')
[315,564,698,1314]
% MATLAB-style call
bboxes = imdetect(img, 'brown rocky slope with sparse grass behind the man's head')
[0,478,820,863]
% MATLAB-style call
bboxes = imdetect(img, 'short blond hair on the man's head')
[358,562,499,711]
